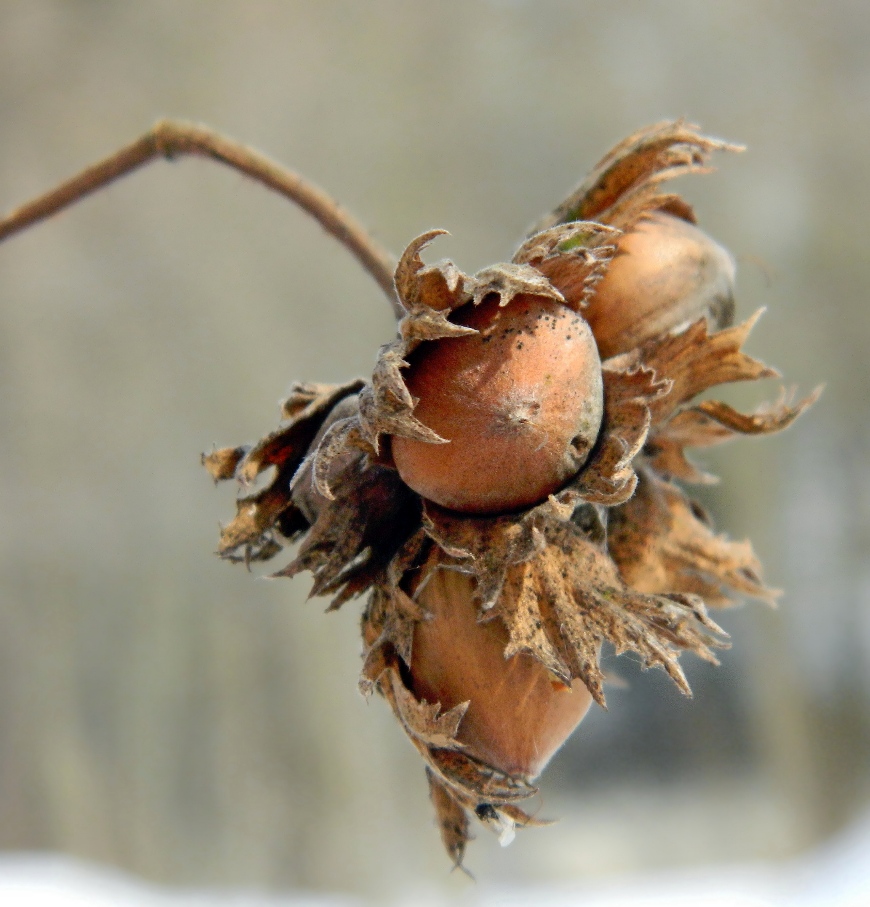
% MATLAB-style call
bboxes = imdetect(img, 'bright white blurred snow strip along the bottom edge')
[0,815,870,907]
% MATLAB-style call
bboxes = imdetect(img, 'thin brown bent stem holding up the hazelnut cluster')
[0,120,404,317]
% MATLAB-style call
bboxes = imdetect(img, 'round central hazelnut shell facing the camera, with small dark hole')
[392,294,603,514]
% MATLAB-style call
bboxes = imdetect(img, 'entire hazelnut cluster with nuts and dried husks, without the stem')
[203,122,815,864]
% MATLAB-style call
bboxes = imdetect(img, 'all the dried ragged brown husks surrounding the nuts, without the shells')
[203,121,817,865]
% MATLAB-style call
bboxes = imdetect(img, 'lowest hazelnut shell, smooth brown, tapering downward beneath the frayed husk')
[411,570,592,780]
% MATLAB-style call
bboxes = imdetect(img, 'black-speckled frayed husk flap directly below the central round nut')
[424,500,722,704]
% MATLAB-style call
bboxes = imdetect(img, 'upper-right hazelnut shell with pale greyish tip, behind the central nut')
[580,211,735,359]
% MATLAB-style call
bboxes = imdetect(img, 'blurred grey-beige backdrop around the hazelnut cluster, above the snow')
[0,0,870,900]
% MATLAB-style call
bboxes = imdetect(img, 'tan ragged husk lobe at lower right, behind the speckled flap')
[608,471,776,605]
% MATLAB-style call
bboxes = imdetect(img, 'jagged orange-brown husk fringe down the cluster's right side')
[606,312,821,606]
